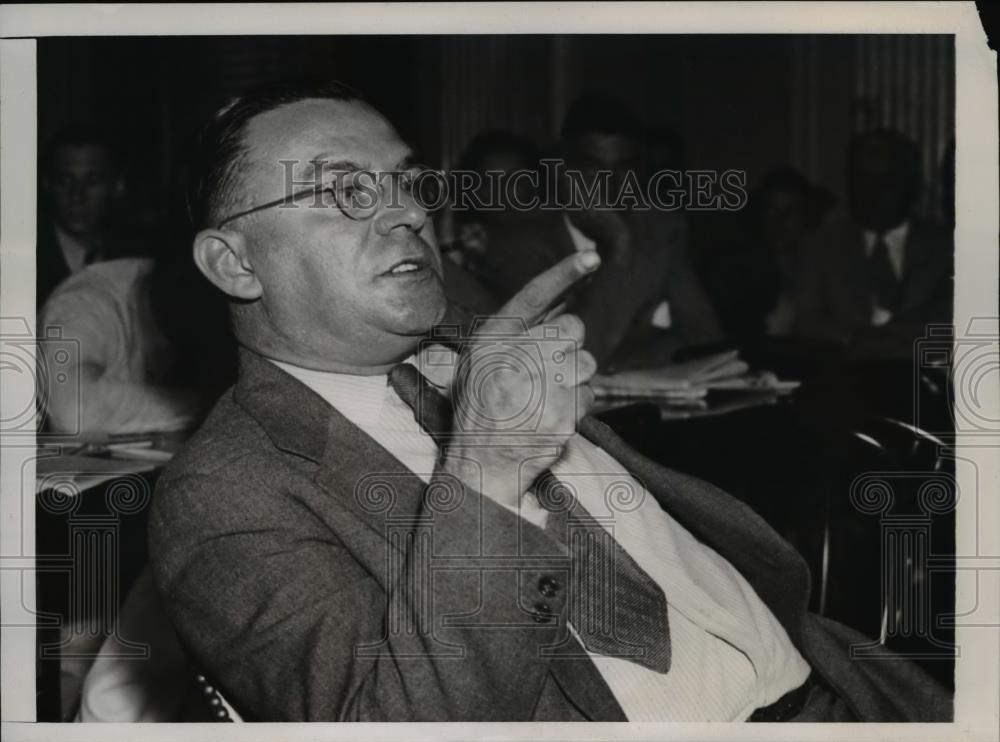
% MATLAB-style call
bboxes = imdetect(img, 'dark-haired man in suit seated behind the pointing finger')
[483,94,722,369]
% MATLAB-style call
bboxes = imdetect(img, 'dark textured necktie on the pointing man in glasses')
[389,364,670,673]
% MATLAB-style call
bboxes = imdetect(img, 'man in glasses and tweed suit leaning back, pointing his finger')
[150,84,950,721]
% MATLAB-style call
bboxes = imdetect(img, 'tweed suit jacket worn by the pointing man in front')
[150,351,950,721]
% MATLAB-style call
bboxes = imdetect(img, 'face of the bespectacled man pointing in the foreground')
[233,100,445,367]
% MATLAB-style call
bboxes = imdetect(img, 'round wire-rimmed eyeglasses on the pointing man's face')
[216,166,447,229]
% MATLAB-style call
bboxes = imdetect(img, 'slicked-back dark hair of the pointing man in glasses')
[187,80,364,229]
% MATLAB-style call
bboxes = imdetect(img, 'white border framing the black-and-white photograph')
[0,2,1000,742]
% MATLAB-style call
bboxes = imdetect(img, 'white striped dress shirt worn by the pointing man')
[275,358,809,721]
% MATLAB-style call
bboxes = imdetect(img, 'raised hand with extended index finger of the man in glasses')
[442,252,600,507]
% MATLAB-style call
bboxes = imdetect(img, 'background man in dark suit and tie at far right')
[795,129,954,360]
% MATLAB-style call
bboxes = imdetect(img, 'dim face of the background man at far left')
[48,144,118,237]
